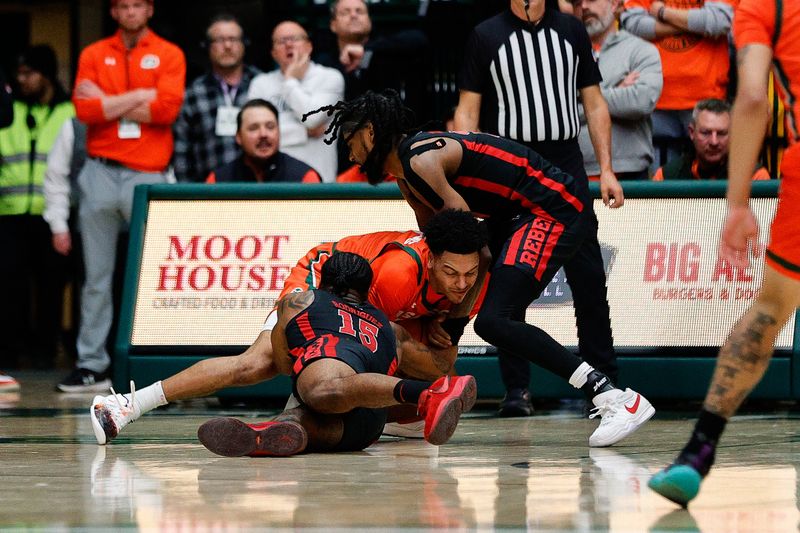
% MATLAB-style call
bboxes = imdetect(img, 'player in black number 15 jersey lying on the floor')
[197,252,477,456]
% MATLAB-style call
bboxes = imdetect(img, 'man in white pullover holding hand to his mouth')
[248,21,344,182]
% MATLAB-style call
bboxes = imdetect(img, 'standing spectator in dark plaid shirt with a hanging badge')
[173,13,261,182]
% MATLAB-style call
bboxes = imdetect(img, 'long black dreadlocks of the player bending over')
[303,89,414,185]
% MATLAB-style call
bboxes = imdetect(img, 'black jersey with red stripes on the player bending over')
[398,132,590,224]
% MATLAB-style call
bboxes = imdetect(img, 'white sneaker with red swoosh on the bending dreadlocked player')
[589,389,656,447]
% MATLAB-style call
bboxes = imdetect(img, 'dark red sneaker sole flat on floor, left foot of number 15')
[197,418,308,457]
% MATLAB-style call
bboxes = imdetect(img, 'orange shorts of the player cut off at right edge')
[765,145,800,280]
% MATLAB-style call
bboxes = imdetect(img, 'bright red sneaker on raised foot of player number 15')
[417,376,478,446]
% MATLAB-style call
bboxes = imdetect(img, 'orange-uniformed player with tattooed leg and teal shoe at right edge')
[649,0,800,507]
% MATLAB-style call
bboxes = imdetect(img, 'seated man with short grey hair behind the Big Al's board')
[653,98,769,181]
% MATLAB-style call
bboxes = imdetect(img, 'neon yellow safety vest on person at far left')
[0,100,75,216]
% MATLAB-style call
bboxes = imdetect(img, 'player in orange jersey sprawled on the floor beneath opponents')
[90,211,487,444]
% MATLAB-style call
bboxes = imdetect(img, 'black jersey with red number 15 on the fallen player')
[286,289,397,364]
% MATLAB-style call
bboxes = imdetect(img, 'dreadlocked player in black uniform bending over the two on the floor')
[304,91,655,446]
